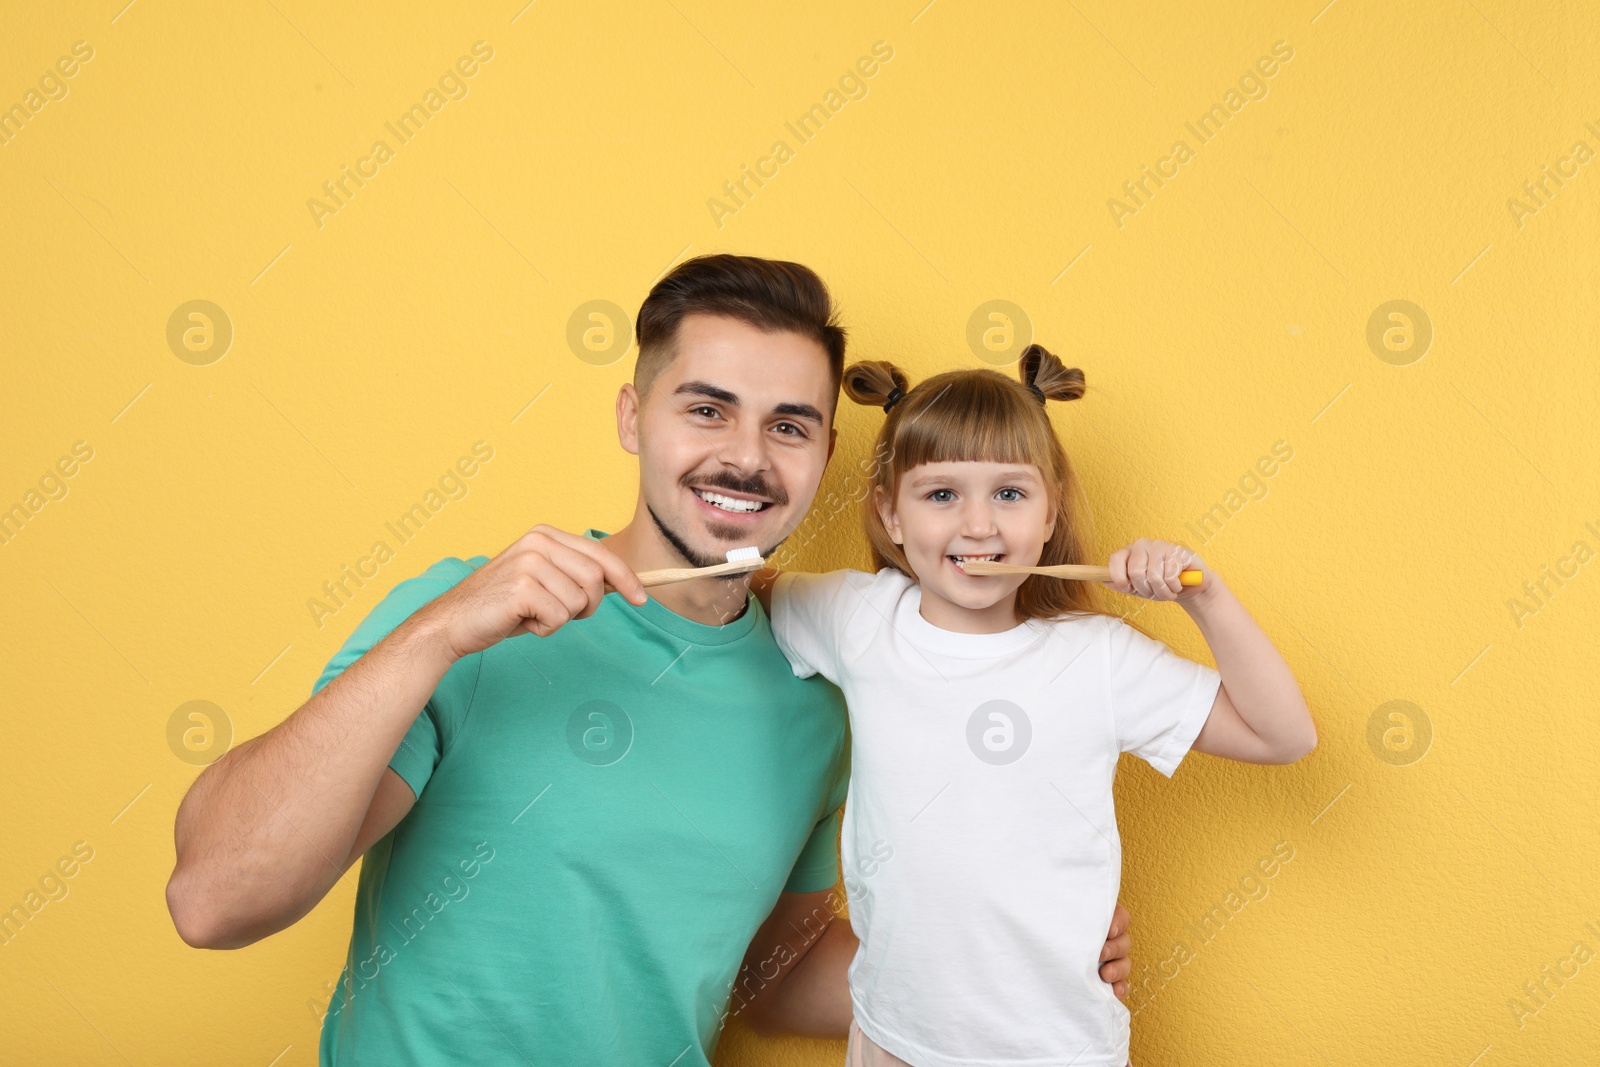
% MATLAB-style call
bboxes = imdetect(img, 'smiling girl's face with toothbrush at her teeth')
[877,461,1056,633]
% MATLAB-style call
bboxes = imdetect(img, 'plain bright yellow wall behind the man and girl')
[0,0,1600,1067]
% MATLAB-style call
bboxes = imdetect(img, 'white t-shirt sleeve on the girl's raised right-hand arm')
[1110,619,1222,777]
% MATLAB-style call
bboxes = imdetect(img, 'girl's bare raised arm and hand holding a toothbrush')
[1109,537,1317,763]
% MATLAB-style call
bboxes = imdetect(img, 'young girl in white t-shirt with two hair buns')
[770,346,1317,1067]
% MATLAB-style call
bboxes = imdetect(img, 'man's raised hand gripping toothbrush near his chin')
[416,523,648,659]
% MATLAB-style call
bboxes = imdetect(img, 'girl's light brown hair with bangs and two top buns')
[843,344,1112,619]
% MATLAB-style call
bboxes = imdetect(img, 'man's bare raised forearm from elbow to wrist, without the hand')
[166,617,450,947]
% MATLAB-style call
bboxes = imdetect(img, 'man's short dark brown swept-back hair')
[634,254,845,400]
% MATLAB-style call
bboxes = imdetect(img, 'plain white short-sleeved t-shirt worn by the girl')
[771,569,1222,1067]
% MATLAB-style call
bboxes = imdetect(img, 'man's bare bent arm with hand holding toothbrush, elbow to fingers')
[166,526,646,949]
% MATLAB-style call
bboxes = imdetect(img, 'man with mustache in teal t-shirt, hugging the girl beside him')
[166,256,1130,1067]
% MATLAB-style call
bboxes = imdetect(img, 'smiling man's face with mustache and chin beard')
[618,315,835,566]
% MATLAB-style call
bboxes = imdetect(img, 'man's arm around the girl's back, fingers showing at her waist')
[728,889,1133,1040]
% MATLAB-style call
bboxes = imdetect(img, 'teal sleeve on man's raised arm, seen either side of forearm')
[310,557,488,797]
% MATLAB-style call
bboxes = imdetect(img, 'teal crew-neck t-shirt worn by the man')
[312,530,848,1067]
